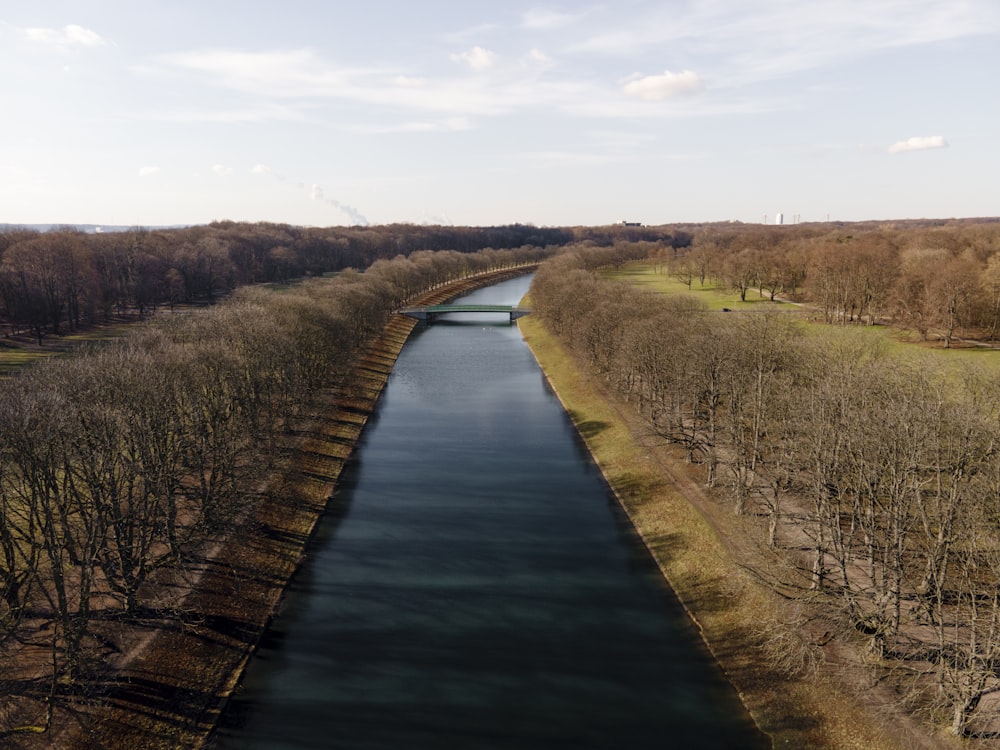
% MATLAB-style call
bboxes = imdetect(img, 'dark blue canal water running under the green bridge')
[215,278,769,750]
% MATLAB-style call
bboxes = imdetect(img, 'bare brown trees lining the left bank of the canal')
[0,247,549,736]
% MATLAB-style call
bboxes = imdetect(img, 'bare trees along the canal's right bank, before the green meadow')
[531,244,1000,736]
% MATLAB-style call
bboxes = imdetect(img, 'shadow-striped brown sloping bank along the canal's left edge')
[38,266,533,750]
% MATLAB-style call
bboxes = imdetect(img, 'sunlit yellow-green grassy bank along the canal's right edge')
[519,318,955,750]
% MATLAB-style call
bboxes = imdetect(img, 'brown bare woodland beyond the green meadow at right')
[665,220,1000,347]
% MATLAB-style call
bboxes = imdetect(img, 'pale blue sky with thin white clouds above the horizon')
[0,0,1000,226]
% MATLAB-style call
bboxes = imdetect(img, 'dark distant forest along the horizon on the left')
[0,222,690,339]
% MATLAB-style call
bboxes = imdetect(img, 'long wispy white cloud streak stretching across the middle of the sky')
[137,38,764,127]
